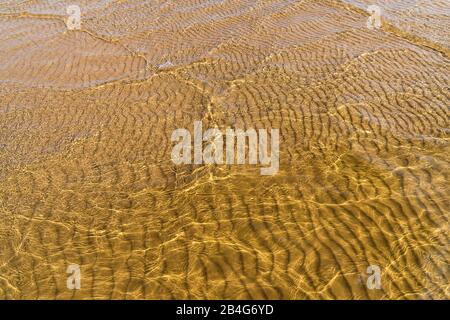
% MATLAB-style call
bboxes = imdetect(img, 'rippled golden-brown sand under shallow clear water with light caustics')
[0,0,450,299]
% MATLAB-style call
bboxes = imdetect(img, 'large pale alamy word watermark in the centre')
[171,121,280,175]
